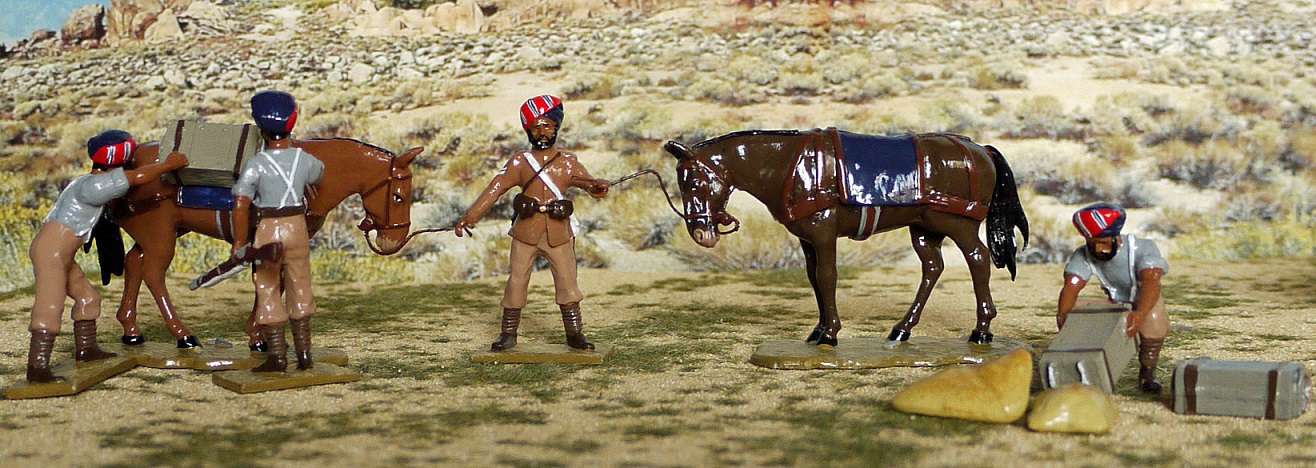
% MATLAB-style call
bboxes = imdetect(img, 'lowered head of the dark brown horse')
[663,141,740,247]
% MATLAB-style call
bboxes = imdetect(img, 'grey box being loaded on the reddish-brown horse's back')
[159,120,265,188]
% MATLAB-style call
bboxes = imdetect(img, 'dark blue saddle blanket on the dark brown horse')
[837,131,920,206]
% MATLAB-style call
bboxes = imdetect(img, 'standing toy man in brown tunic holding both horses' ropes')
[457,95,609,351]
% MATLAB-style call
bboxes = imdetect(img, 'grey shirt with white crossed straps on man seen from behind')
[233,147,325,208]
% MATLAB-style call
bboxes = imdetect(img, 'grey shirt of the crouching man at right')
[1065,234,1170,304]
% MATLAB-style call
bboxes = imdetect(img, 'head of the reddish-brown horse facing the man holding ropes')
[357,147,425,255]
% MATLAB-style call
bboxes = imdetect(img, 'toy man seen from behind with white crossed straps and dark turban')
[233,91,324,372]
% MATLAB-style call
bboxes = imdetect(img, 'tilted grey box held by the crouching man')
[1037,304,1138,393]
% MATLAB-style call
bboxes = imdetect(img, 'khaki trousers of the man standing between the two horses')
[503,233,584,309]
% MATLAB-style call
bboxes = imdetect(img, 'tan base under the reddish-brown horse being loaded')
[113,342,347,371]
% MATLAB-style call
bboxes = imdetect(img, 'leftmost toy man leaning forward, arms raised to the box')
[28,130,187,383]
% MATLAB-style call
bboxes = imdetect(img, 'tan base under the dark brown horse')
[749,337,1034,369]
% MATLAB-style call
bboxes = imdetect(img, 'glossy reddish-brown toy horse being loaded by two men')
[114,138,424,348]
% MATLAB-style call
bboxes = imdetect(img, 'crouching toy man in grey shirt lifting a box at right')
[1055,204,1170,393]
